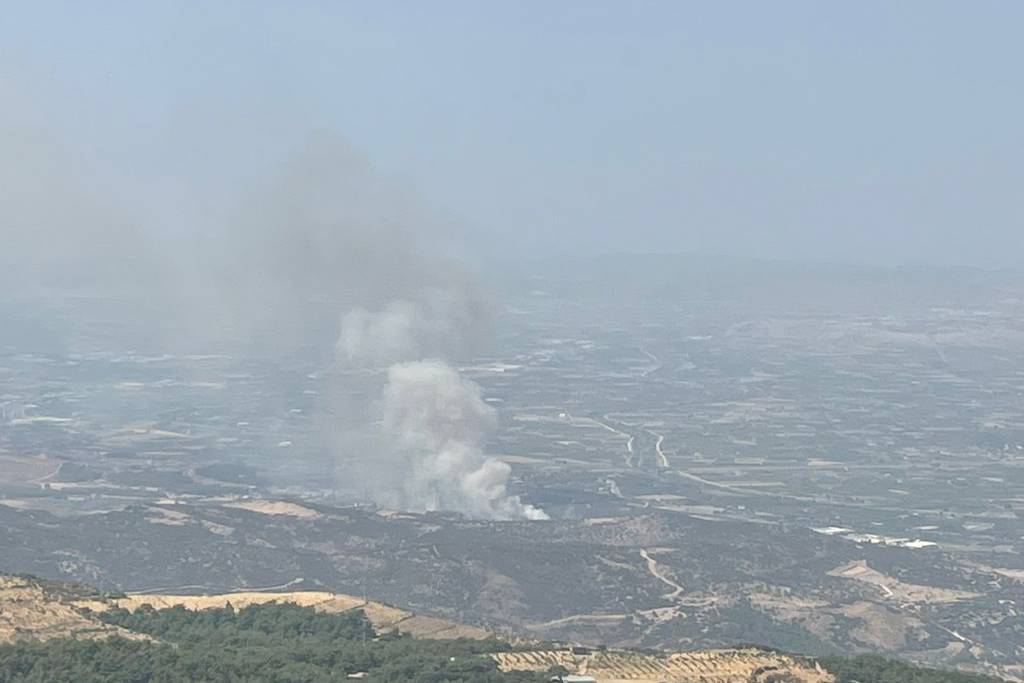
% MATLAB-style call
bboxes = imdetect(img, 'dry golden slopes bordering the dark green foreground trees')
[0,577,833,683]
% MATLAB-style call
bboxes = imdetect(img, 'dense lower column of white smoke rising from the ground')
[380,360,548,519]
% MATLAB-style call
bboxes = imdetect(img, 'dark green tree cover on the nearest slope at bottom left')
[0,603,550,683]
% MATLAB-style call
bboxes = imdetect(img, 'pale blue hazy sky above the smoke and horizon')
[0,0,1024,265]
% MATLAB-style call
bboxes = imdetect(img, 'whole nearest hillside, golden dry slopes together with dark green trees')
[0,575,995,683]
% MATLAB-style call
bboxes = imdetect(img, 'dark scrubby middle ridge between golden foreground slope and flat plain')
[0,497,1024,680]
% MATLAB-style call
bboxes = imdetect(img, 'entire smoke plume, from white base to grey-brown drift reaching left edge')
[0,85,543,519]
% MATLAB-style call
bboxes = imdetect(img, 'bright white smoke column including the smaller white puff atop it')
[337,301,548,519]
